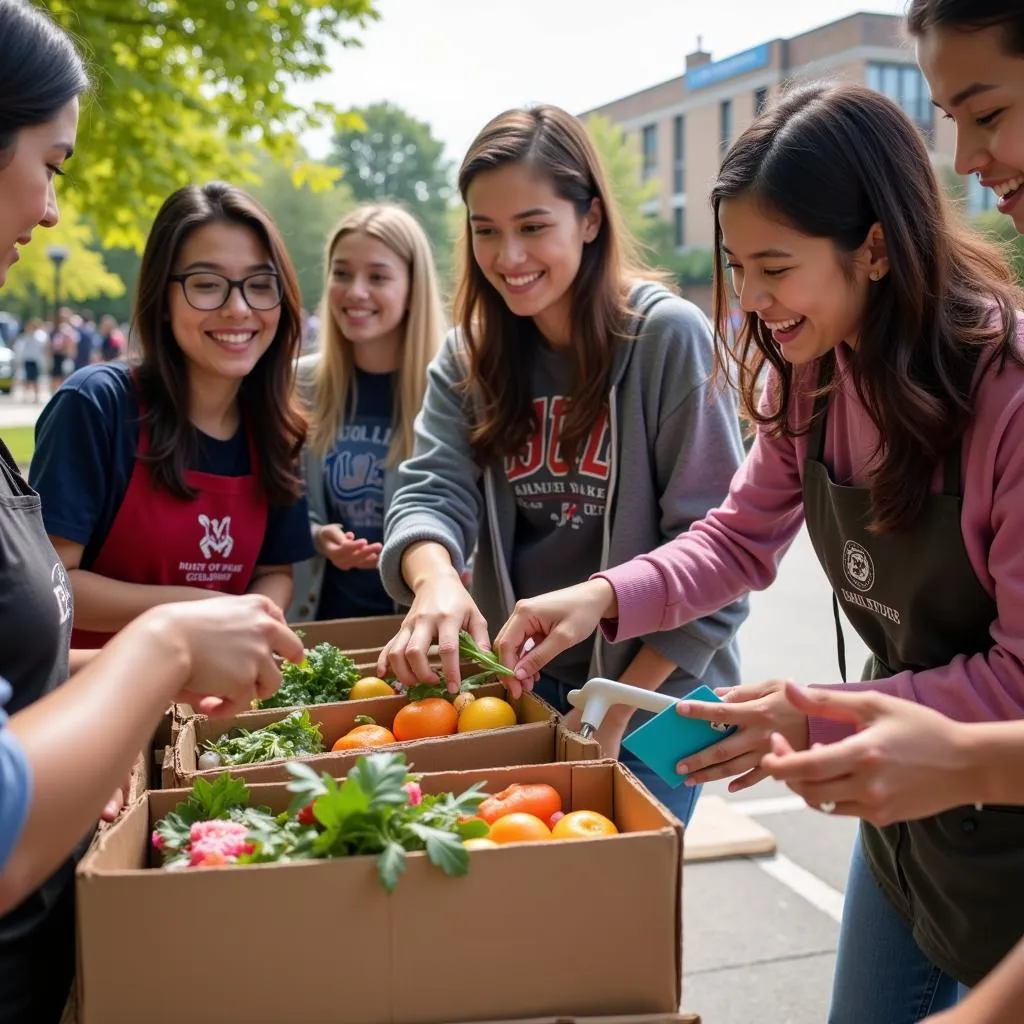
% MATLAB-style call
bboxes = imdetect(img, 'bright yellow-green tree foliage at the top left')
[42,0,378,249]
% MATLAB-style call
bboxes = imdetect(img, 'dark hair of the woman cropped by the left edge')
[0,0,89,155]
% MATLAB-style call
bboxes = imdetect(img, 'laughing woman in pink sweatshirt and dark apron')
[499,85,1024,1024]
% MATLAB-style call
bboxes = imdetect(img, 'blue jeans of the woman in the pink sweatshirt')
[828,836,969,1024]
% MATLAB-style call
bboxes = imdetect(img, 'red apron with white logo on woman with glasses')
[71,408,267,648]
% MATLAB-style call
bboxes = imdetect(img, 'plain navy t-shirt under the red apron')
[29,362,313,568]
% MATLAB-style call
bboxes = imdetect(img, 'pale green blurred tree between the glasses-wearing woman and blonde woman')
[252,156,355,309]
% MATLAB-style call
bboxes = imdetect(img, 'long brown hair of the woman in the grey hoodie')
[455,105,658,465]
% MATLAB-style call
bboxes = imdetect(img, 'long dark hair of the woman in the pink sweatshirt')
[711,85,1018,532]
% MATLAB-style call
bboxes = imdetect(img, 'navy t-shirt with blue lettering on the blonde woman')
[316,370,395,618]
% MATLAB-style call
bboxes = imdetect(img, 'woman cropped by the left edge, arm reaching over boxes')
[0,0,302,1024]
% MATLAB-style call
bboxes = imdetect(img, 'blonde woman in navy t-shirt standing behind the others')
[289,204,444,622]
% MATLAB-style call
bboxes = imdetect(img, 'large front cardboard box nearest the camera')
[77,761,683,1024]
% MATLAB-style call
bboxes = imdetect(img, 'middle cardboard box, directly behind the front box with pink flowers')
[164,683,601,788]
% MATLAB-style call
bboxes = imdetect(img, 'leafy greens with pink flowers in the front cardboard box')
[153,753,487,892]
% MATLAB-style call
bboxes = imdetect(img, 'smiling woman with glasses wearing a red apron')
[30,183,312,647]
